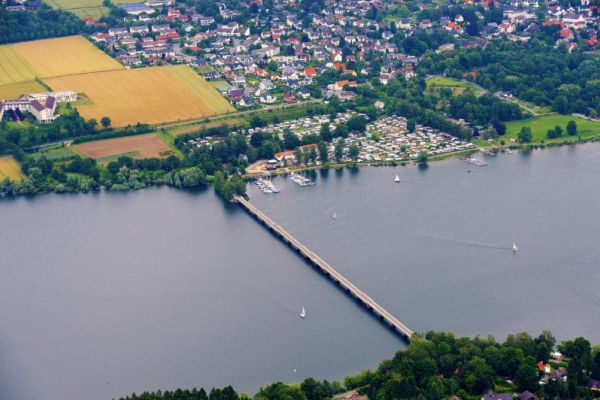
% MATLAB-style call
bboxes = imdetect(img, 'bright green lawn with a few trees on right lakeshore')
[505,114,600,142]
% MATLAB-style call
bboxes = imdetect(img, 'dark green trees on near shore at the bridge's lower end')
[121,331,600,400]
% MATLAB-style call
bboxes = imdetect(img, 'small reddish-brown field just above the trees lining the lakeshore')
[75,133,173,161]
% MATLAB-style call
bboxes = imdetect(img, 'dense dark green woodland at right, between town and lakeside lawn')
[418,38,600,117]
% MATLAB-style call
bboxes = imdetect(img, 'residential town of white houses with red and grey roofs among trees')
[72,0,598,108]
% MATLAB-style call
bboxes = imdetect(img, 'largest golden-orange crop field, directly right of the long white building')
[44,66,234,127]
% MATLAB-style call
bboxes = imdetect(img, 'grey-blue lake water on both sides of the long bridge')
[0,144,600,400]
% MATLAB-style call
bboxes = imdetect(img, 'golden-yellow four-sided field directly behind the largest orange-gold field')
[12,36,124,78]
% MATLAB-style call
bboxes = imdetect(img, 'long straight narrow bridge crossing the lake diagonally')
[233,196,413,341]
